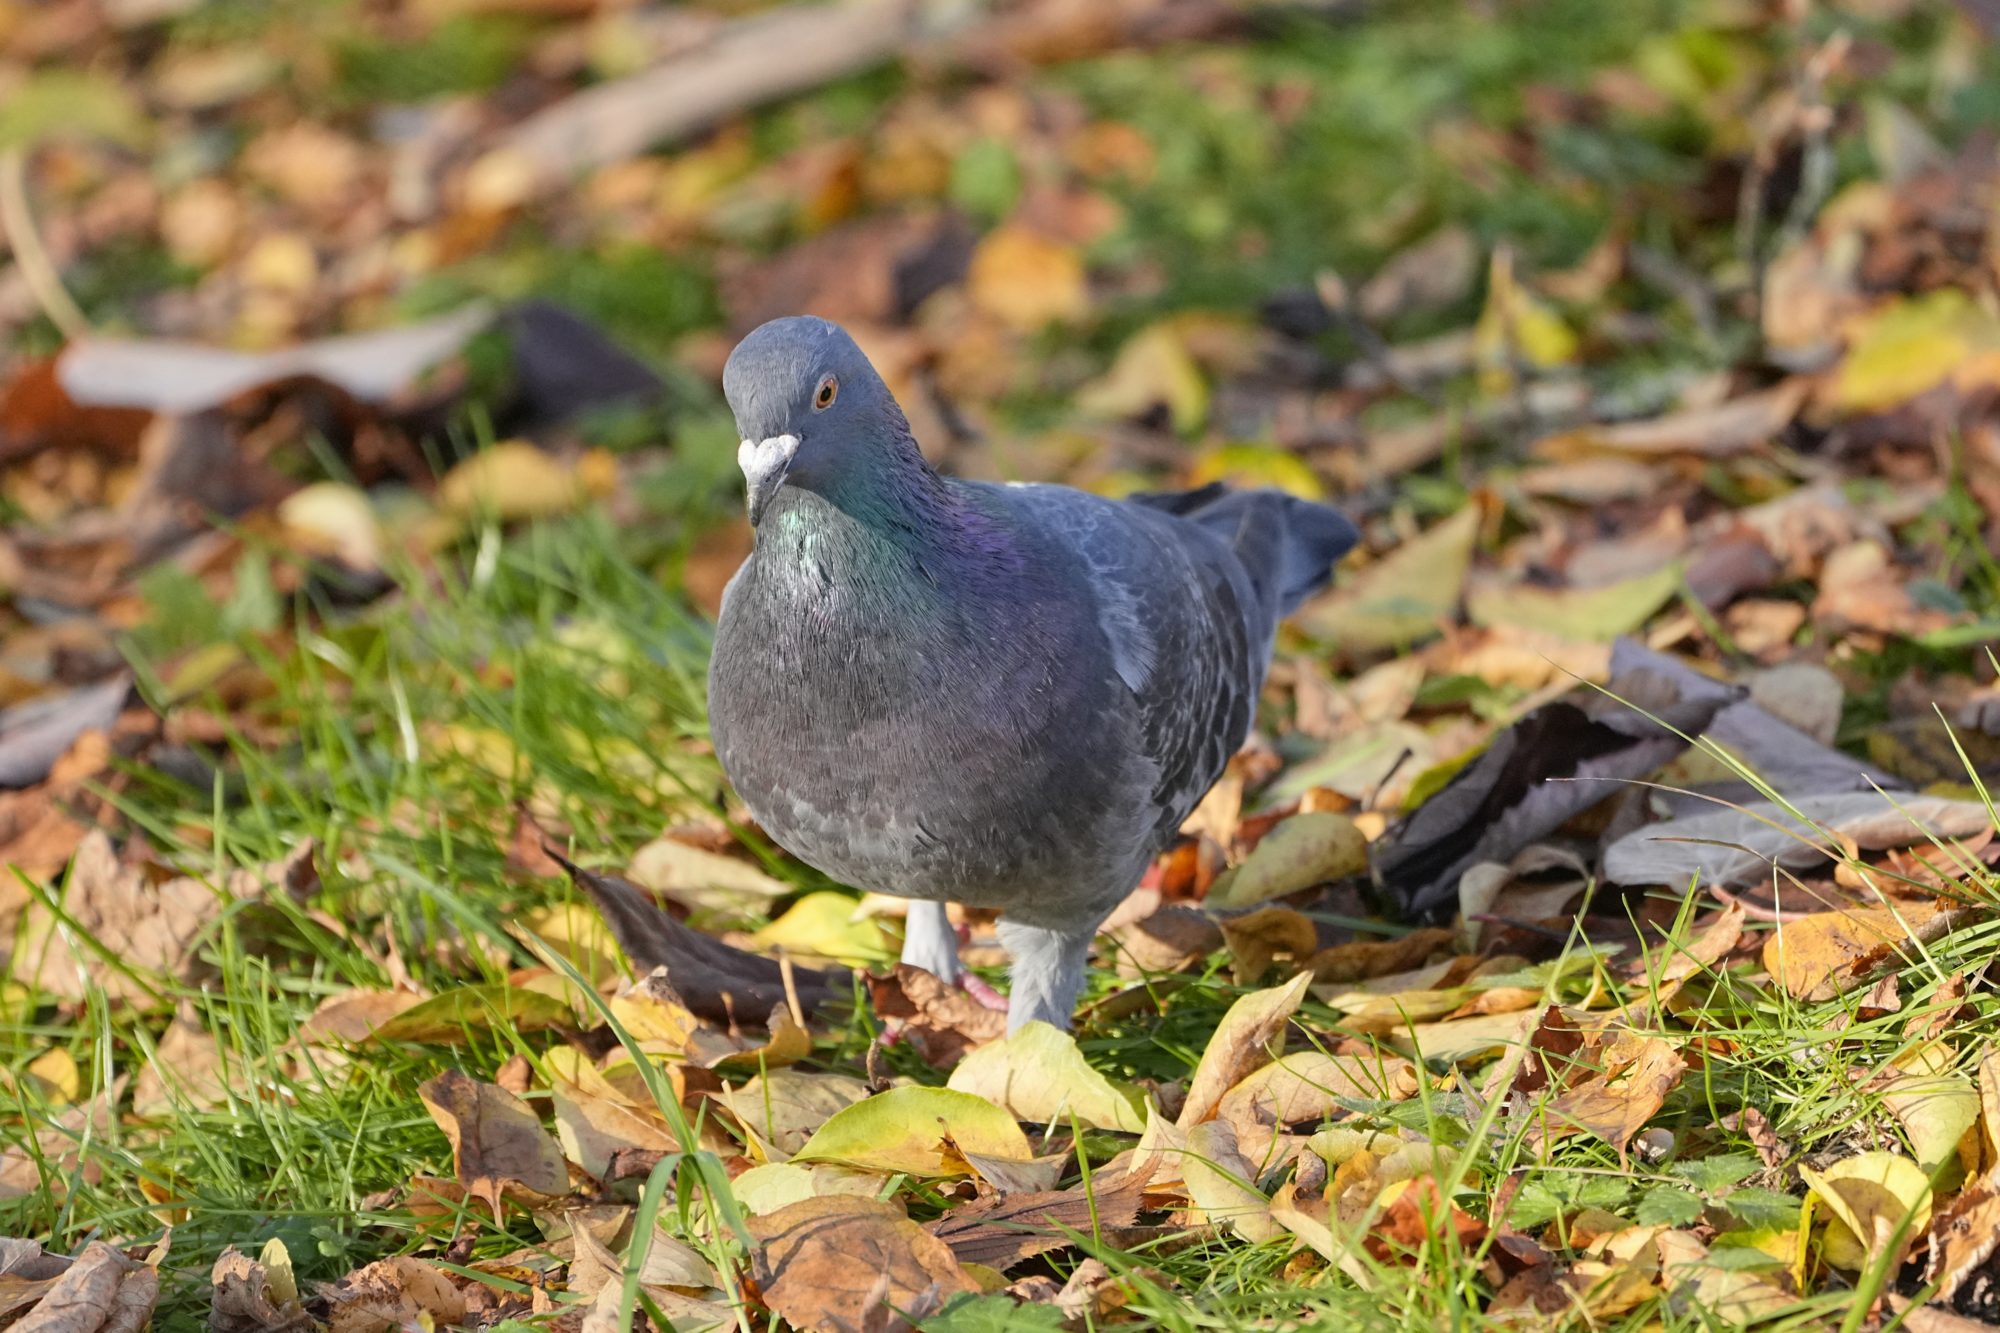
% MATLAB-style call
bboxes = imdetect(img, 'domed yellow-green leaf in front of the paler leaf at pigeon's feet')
[792,1087,1034,1179]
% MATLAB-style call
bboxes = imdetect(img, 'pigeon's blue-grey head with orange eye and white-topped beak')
[722,314,908,524]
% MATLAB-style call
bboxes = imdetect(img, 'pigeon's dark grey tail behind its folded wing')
[1130,482,1360,618]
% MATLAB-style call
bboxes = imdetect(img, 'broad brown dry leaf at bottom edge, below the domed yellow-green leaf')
[750,1195,978,1331]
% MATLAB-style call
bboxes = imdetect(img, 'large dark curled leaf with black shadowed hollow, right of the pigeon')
[1374,669,1738,921]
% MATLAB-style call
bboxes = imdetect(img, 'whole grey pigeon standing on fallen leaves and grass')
[708,316,1356,1031]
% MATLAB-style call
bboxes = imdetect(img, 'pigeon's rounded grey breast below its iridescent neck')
[708,548,1150,907]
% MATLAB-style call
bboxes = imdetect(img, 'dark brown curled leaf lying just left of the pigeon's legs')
[548,849,852,1023]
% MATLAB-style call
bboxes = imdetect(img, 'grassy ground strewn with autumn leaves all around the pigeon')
[0,0,2000,1331]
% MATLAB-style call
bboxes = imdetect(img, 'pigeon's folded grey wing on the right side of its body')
[988,486,1274,843]
